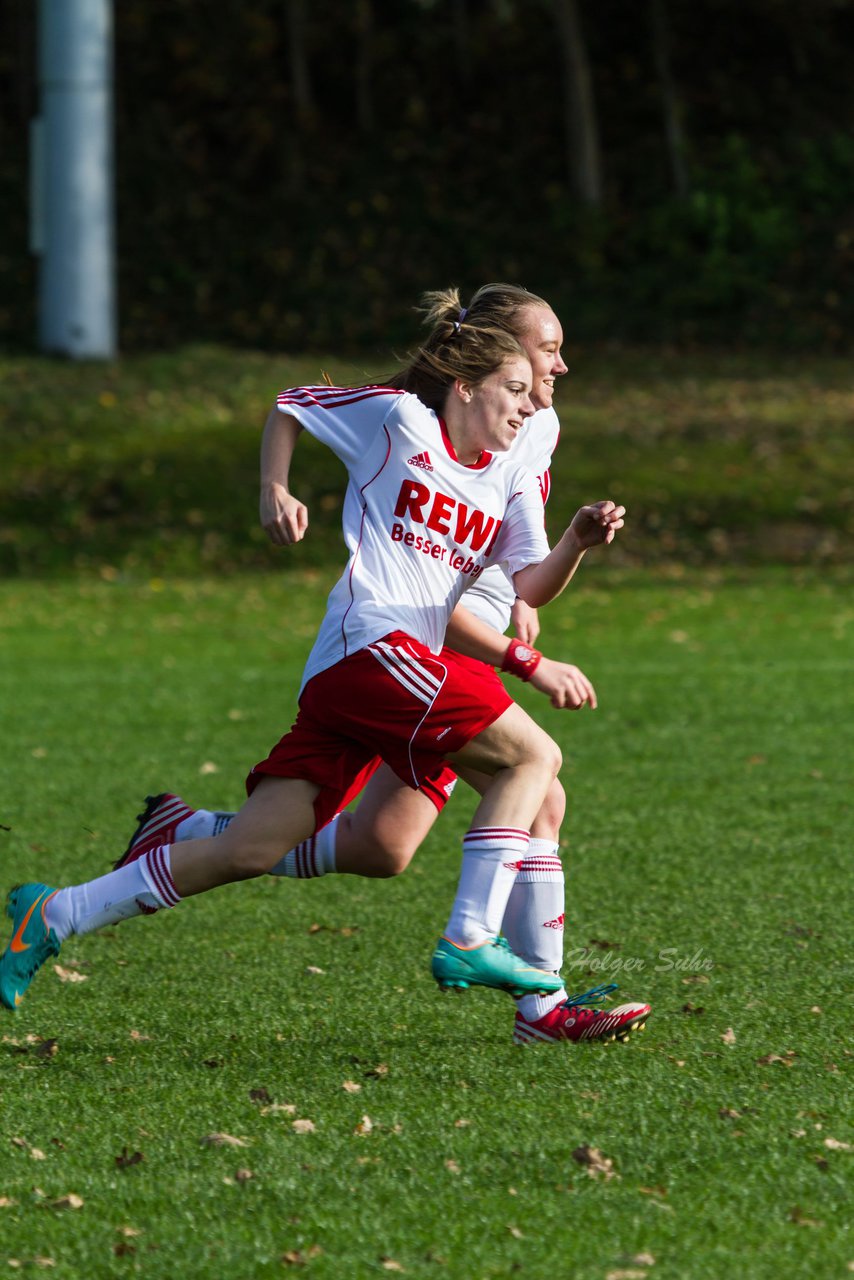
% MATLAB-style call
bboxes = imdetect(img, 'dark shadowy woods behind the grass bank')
[0,0,854,352]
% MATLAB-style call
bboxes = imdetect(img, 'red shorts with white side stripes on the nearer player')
[246,631,512,828]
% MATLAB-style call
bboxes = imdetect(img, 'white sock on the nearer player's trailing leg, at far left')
[45,845,181,942]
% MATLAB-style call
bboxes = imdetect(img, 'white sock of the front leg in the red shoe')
[502,838,566,1021]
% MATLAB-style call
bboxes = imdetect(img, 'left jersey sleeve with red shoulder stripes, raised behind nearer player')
[275,387,402,471]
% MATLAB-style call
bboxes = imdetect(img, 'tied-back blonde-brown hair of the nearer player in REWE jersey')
[392,285,533,412]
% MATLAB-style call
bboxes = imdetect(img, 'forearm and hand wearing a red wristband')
[444,604,597,710]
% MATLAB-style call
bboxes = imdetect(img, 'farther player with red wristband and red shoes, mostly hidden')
[112,284,649,1043]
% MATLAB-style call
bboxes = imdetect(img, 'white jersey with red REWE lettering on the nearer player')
[277,387,549,685]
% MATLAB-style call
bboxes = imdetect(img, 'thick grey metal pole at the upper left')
[32,0,117,360]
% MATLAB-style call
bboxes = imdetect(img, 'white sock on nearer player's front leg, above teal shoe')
[444,827,530,947]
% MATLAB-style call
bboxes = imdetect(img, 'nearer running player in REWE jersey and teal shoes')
[0,305,625,1009]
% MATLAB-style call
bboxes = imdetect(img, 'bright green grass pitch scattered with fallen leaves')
[0,568,854,1280]
